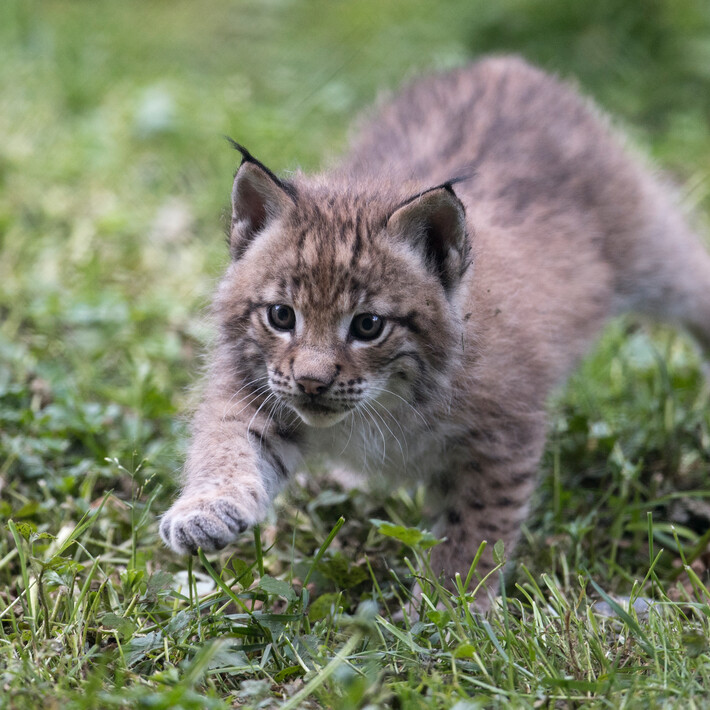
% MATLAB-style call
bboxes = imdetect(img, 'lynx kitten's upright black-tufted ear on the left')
[229,146,296,260]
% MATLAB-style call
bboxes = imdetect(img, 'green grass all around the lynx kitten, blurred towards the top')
[0,0,710,710]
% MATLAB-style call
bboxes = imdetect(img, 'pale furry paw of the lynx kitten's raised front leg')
[160,498,256,555]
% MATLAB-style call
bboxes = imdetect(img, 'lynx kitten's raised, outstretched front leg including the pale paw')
[160,397,294,554]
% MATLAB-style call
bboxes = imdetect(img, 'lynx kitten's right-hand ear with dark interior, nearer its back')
[387,183,470,291]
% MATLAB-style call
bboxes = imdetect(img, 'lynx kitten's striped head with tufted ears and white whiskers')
[216,149,470,427]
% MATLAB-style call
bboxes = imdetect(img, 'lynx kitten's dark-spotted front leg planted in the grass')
[432,417,545,609]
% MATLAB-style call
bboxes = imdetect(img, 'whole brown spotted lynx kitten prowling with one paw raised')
[160,57,710,600]
